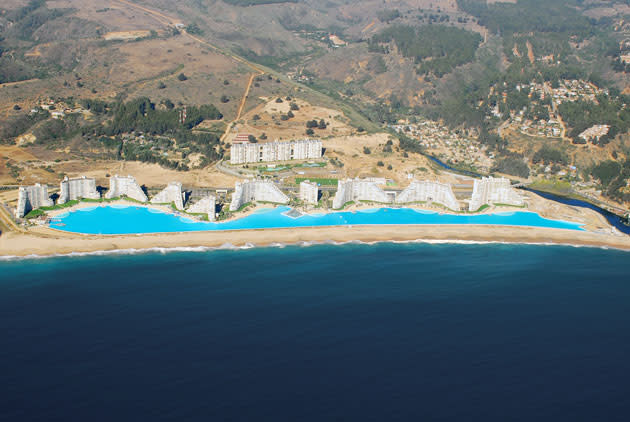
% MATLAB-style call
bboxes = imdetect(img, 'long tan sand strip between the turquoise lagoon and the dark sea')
[0,225,630,259]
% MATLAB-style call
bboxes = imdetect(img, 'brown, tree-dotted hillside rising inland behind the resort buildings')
[0,0,630,205]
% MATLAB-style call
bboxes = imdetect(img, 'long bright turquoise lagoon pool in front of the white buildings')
[50,205,583,234]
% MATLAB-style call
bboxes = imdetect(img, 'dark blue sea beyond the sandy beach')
[0,244,630,421]
